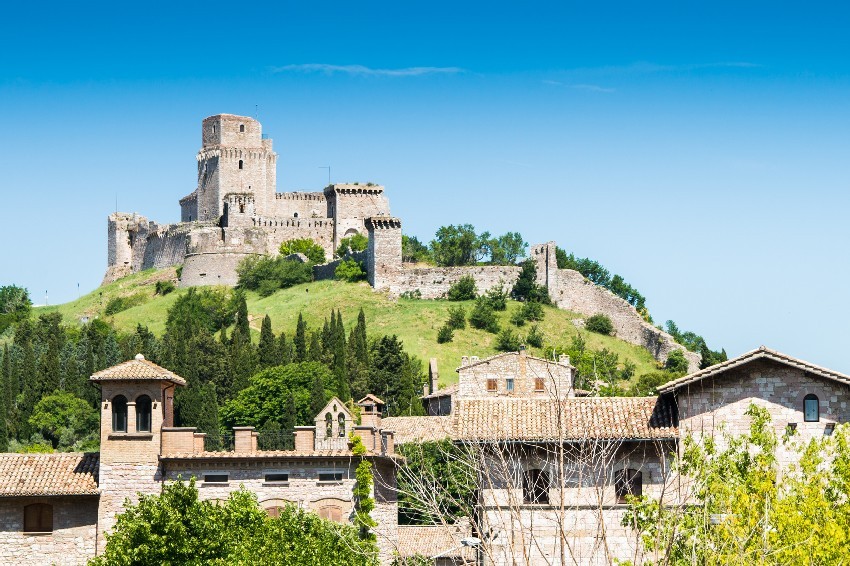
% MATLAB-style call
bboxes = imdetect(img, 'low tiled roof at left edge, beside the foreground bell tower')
[0,452,100,497]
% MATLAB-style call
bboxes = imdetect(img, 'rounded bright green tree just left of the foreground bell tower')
[29,391,100,451]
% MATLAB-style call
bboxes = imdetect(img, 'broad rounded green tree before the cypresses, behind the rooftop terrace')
[220,362,335,429]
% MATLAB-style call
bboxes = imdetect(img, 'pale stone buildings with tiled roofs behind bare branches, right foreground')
[384,347,850,564]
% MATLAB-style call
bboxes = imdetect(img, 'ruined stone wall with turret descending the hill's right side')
[531,242,701,372]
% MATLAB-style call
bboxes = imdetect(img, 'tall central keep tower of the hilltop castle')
[189,114,277,222]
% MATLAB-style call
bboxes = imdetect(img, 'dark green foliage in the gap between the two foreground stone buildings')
[396,439,478,525]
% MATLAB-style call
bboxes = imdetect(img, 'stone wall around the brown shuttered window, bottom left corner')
[0,496,98,565]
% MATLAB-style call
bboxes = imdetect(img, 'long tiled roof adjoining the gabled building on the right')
[452,397,678,442]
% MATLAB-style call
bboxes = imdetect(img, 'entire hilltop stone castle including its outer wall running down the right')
[103,114,700,371]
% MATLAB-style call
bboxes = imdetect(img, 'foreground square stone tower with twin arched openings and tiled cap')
[90,354,186,552]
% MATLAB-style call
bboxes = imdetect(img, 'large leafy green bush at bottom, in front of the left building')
[89,479,377,566]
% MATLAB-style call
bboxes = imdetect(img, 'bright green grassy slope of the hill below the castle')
[35,269,656,390]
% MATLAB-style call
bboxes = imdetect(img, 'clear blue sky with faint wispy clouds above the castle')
[0,1,850,373]
